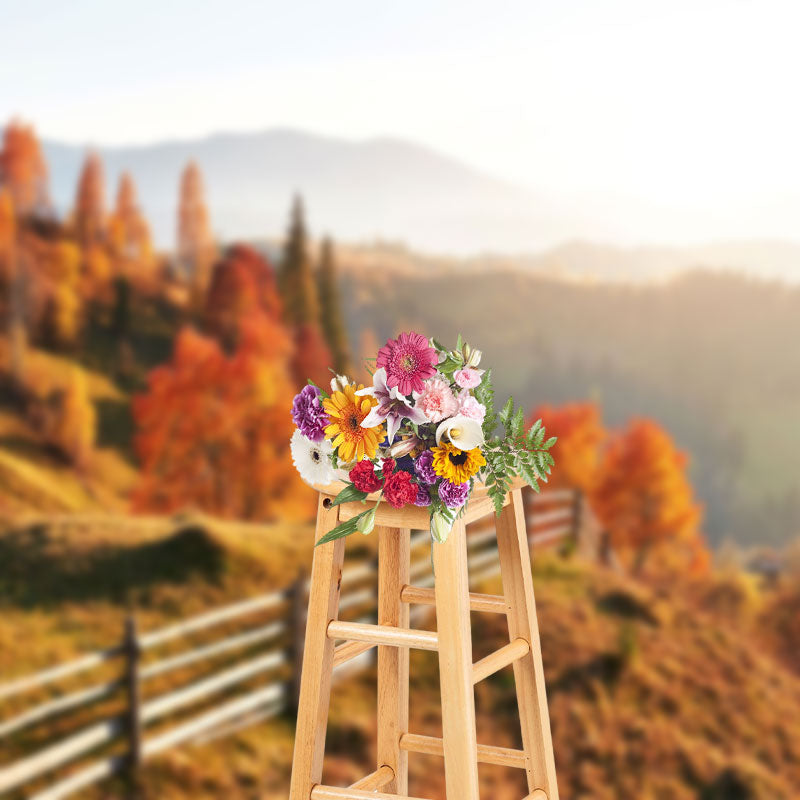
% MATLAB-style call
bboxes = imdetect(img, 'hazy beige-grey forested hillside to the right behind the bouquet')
[342,266,800,544]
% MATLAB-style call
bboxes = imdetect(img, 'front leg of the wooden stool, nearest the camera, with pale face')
[433,520,479,800]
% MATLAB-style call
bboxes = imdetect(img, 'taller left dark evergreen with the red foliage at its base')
[278,197,332,385]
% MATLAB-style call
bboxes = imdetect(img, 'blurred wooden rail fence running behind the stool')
[0,490,595,800]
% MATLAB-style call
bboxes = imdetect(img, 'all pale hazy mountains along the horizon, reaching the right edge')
[34,129,800,281]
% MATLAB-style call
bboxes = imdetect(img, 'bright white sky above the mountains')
[0,0,800,240]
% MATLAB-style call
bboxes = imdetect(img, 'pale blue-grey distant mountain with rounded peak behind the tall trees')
[45,130,568,253]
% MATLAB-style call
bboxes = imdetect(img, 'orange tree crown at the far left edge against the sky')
[0,120,50,216]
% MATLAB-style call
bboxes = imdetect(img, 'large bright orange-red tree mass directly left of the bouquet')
[133,314,310,519]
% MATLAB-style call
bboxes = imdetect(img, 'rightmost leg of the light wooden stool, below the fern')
[497,489,558,800]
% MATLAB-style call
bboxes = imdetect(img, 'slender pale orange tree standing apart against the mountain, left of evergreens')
[178,161,216,292]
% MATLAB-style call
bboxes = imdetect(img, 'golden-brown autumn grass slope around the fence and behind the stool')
[0,518,800,800]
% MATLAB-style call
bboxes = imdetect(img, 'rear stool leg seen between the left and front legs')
[376,528,411,795]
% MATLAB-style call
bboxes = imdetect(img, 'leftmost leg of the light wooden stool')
[289,495,345,800]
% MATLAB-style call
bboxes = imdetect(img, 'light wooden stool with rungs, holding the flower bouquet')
[289,484,558,800]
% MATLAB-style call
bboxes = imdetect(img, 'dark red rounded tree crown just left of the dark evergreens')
[204,244,282,350]
